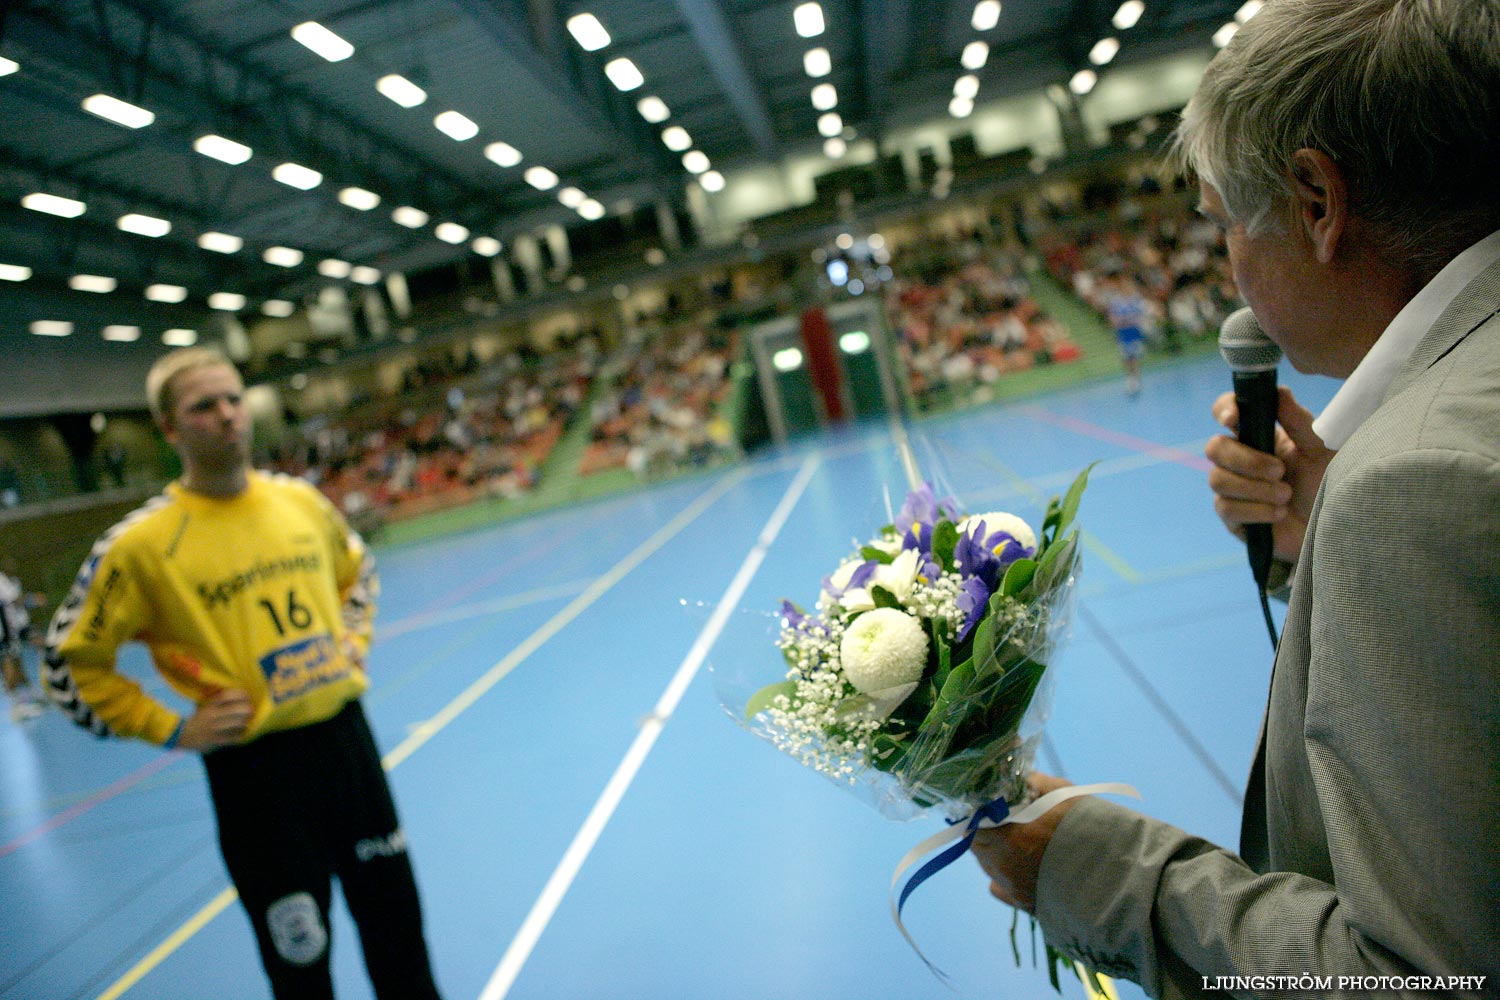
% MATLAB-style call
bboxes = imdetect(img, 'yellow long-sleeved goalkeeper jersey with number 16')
[45,472,380,744]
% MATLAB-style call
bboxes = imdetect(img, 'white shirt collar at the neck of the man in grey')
[1313,232,1500,451]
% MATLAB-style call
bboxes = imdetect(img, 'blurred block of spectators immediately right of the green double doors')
[887,235,1080,406]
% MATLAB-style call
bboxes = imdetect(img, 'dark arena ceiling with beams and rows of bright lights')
[0,0,1241,407]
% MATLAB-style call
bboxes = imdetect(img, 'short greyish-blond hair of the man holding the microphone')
[1172,0,1500,270]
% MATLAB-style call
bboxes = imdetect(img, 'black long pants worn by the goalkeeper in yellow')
[204,702,438,1000]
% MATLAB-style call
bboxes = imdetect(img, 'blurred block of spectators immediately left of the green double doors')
[579,324,738,478]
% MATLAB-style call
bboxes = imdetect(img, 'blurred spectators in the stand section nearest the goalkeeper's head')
[273,339,599,532]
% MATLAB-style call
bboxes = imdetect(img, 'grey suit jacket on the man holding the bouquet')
[1037,254,1500,997]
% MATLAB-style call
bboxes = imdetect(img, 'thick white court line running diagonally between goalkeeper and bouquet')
[480,454,821,1000]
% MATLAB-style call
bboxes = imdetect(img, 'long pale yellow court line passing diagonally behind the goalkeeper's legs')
[87,466,746,1000]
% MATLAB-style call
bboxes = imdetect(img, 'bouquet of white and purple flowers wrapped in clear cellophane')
[744,469,1089,820]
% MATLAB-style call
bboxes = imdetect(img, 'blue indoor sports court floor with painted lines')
[0,357,1335,1000]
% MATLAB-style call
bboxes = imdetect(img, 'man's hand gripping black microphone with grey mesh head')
[1205,309,1334,586]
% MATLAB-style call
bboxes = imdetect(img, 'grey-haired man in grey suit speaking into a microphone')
[974,0,1500,997]
